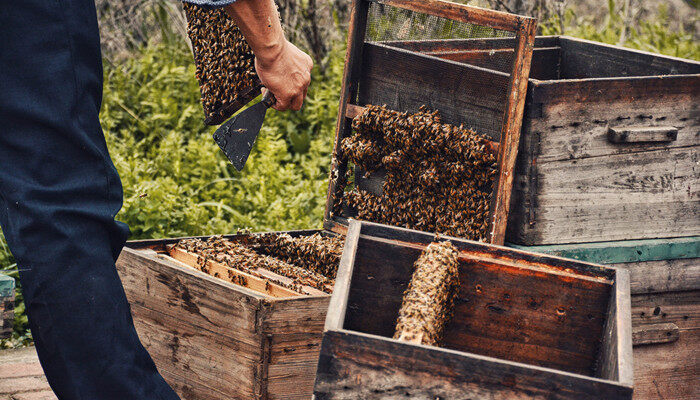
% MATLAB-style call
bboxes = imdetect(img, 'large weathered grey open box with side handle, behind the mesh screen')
[390,36,700,245]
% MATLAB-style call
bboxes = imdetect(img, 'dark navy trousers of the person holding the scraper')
[0,0,178,400]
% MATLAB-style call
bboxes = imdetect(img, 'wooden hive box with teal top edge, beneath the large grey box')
[510,236,700,399]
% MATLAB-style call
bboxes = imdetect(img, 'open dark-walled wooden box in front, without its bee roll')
[314,221,633,400]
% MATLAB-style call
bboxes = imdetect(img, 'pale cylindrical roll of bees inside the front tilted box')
[394,241,459,346]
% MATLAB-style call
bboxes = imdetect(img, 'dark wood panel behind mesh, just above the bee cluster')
[356,43,509,141]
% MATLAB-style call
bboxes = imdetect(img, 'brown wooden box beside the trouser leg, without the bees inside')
[117,231,330,400]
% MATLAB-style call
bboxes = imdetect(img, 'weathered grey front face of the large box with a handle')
[507,57,700,245]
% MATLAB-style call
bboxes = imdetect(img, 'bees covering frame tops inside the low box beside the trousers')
[176,233,342,294]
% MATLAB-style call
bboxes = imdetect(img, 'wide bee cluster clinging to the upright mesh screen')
[331,105,497,241]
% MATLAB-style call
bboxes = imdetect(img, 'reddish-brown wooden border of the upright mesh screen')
[324,0,537,245]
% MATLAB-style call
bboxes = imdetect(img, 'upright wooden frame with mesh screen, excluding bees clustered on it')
[324,0,537,244]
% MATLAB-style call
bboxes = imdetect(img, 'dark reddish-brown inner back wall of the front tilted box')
[344,233,611,375]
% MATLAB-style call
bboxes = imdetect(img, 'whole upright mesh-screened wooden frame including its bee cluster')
[324,0,537,244]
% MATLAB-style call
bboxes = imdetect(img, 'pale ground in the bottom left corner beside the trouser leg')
[0,347,56,400]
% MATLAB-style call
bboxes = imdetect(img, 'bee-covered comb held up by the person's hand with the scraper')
[183,3,261,124]
